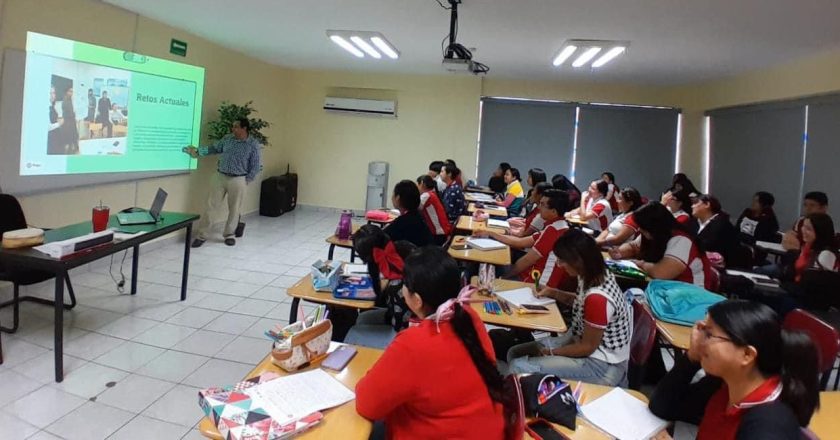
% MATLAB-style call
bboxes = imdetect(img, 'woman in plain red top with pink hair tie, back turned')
[356,247,505,440]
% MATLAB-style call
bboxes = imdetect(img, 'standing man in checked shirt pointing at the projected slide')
[184,118,260,247]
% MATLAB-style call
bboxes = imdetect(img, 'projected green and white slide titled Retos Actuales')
[20,32,204,176]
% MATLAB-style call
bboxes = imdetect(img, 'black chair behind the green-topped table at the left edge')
[0,194,76,333]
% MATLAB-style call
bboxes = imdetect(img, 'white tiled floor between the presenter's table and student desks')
[0,207,349,440]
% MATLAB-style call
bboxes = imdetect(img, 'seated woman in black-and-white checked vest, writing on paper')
[507,229,633,386]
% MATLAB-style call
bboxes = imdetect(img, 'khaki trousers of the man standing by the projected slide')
[198,173,248,240]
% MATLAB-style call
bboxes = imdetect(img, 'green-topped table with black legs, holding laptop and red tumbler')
[0,212,199,382]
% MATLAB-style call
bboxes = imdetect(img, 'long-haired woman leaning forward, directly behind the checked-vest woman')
[610,202,718,291]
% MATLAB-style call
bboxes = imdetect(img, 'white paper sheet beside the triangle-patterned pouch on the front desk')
[245,369,356,425]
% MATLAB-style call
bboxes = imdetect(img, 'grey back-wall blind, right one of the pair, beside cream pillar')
[575,105,679,199]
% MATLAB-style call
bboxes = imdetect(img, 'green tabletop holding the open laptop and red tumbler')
[0,212,199,268]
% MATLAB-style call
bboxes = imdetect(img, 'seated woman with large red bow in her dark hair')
[342,225,418,349]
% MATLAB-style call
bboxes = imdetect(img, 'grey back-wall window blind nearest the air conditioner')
[478,98,575,185]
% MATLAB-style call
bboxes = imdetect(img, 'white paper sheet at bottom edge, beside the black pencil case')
[581,388,668,440]
